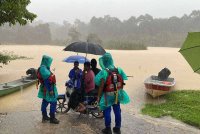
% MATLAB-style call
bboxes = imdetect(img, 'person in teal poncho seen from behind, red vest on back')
[95,53,130,134]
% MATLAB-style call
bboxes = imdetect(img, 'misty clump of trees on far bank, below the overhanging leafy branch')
[0,24,51,44]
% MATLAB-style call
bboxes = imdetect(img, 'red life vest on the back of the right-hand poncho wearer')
[104,68,124,92]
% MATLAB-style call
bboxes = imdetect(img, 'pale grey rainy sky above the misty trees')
[28,0,200,23]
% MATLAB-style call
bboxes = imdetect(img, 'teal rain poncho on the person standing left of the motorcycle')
[38,55,58,102]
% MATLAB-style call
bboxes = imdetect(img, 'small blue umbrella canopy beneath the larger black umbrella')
[63,55,90,64]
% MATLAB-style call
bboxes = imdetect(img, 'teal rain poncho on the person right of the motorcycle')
[95,53,130,110]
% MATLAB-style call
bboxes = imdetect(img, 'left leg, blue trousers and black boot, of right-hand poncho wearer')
[102,107,112,134]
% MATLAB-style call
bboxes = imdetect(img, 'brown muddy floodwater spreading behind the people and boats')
[0,45,200,114]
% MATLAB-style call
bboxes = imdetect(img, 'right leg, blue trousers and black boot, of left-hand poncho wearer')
[50,102,59,124]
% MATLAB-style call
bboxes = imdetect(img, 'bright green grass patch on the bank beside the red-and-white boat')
[141,90,200,128]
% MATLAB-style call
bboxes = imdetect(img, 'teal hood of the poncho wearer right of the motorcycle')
[99,53,115,69]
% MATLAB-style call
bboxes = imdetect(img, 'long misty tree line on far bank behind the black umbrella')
[47,10,200,47]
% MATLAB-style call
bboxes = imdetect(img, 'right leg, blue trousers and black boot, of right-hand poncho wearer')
[113,103,121,134]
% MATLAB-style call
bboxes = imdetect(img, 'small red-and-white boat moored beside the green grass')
[144,75,176,98]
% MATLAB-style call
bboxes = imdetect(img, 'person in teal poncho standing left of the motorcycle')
[37,55,59,124]
